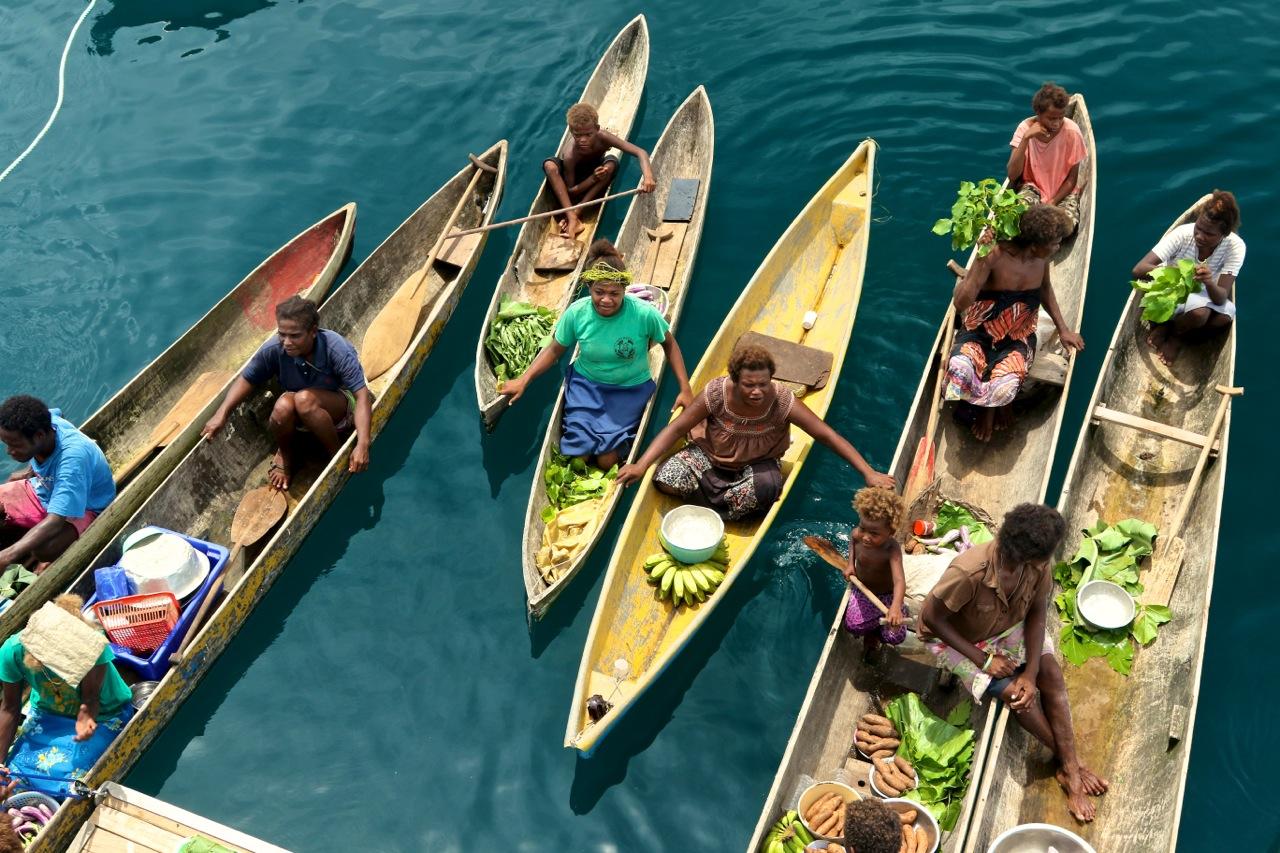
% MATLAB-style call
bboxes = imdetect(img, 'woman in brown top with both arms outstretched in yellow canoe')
[618,346,893,520]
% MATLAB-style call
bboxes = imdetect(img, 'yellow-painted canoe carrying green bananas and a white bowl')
[564,140,876,756]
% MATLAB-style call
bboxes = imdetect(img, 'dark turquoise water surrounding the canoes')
[0,0,1280,852]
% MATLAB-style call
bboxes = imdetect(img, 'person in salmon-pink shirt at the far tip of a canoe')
[1005,83,1087,234]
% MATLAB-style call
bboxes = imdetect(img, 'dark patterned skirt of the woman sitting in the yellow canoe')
[653,443,782,521]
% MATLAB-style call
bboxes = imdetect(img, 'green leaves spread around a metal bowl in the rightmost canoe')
[1053,519,1170,675]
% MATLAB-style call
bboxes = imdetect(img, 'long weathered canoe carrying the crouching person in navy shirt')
[29,141,507,850]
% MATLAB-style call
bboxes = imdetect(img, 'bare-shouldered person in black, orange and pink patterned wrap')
[946,204,1084,442]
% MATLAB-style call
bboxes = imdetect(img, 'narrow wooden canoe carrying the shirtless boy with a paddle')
[475,14,649,430]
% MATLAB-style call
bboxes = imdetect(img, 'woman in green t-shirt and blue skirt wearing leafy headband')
[499,240,694,470]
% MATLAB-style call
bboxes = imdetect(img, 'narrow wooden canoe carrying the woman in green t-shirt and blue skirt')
[521,86,716,619]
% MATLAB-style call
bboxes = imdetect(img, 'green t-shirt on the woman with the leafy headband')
[556,296,669,388]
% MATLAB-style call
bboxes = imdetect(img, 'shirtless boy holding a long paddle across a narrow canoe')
[543,104,658,237]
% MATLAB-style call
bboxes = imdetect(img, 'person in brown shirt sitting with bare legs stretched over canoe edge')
[919,503,1107,822]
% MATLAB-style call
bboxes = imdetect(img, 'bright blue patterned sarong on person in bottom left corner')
[5,704,133,799]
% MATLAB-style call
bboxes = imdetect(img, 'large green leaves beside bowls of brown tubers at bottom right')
[884,693,974,831]
